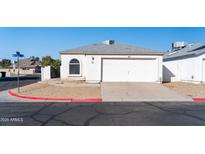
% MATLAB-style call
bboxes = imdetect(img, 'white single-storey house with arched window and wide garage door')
[60,40,163,82]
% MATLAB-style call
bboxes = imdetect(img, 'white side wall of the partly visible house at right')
[163,55,205,82]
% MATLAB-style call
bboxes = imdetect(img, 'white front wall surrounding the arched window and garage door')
[61,54,162,82]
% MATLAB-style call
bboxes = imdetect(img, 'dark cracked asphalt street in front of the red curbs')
[0,81,205,126]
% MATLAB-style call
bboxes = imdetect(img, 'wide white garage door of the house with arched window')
[102,59,157,82]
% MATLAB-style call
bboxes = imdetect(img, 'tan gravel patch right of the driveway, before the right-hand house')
[163,82,205,98]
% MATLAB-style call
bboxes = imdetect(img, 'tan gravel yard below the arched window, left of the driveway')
[14,83,101,98]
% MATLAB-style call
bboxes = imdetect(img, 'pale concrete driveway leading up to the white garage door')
[101,82,192,102]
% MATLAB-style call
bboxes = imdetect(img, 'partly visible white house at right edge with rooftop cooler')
[163,42,205,83]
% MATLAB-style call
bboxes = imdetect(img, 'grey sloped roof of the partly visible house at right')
[163,44,205,61]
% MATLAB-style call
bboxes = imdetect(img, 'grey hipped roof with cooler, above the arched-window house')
[60,40,164,55]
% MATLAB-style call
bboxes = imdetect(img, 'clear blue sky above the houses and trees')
[0,27,205,59]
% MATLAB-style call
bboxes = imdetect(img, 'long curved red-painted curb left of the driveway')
[8,90,102,103]
